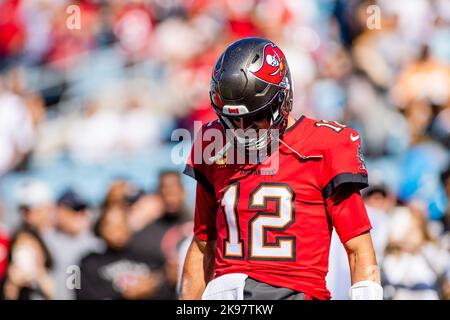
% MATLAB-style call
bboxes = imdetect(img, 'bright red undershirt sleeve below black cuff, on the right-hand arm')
[326,185,372,243]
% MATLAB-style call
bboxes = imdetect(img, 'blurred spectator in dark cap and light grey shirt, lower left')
[44,190,102,300]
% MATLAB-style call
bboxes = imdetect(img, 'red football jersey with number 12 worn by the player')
[184,116,371,299]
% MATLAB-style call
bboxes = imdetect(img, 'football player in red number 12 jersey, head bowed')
[180,38,383,300]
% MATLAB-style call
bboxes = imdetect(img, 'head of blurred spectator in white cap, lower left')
[16,179,54,235]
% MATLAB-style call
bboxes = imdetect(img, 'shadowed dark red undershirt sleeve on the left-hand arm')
[194,183,218,241]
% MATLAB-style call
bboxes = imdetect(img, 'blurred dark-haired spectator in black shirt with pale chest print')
[76,205,162,300]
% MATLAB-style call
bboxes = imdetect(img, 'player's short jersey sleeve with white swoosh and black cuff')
[322,128,368,199]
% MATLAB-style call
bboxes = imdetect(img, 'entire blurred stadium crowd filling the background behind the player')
[0,0,450,299]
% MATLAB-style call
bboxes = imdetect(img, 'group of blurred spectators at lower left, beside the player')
[0,171,193,299]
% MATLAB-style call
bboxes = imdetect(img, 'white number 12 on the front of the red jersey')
[221,182,296,261]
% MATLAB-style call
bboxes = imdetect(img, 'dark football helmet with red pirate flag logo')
[210,38,293,150]
